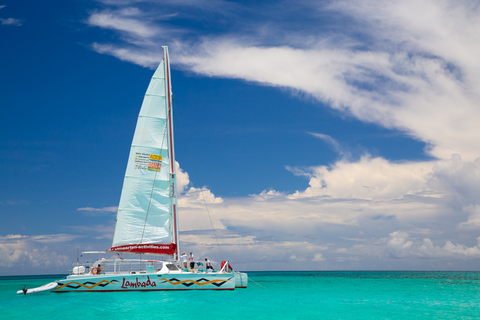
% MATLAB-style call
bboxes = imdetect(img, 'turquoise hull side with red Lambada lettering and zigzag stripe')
[52,273,235,293]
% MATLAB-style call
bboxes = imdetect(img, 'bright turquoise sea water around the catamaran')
[0,271,480,320]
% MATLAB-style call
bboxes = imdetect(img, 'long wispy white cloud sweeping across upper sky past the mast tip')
[84,0,480,160]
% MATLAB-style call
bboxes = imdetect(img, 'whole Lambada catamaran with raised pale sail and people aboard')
[17,47,248,294]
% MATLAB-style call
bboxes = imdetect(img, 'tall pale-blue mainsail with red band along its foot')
[110,47,178,259]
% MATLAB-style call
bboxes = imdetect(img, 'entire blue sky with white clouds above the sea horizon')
[0,0,480,274]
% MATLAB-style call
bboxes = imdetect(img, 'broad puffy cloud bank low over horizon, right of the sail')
[176,157,480,269]
